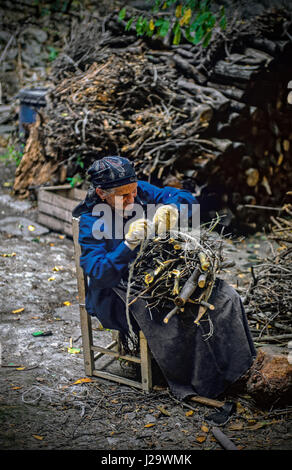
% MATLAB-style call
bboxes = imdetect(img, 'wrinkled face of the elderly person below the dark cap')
[96,183,137,210]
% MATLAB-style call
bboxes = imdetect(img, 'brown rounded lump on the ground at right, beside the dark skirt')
[246,346,292,408]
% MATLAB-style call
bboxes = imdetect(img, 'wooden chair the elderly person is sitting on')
[72,217,152,392]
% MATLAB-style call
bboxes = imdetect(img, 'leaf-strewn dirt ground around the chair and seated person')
[0,162,292,452]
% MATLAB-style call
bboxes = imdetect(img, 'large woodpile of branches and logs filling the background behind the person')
[14,3,292,231]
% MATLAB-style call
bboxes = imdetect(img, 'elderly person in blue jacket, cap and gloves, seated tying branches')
[73,156,256,398]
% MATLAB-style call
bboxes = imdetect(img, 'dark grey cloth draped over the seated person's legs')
[114,278,256,399]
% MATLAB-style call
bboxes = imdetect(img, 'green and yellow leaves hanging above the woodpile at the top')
[119,0,226,47]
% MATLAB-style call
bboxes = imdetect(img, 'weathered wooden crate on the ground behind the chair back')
[38,184,86,236]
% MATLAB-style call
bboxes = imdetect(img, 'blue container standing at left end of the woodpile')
[17,88,48,141]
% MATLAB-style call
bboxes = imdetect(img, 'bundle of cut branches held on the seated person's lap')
[127,220,234,325]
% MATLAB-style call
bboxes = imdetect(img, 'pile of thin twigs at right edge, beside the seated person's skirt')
[245,213,292,346]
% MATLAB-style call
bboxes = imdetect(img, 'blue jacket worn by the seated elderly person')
[73,181,197,333]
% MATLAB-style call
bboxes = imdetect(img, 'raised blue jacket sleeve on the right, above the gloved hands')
[138,181,198,217]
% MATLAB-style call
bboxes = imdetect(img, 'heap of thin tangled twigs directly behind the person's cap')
[44,48,213,178]
